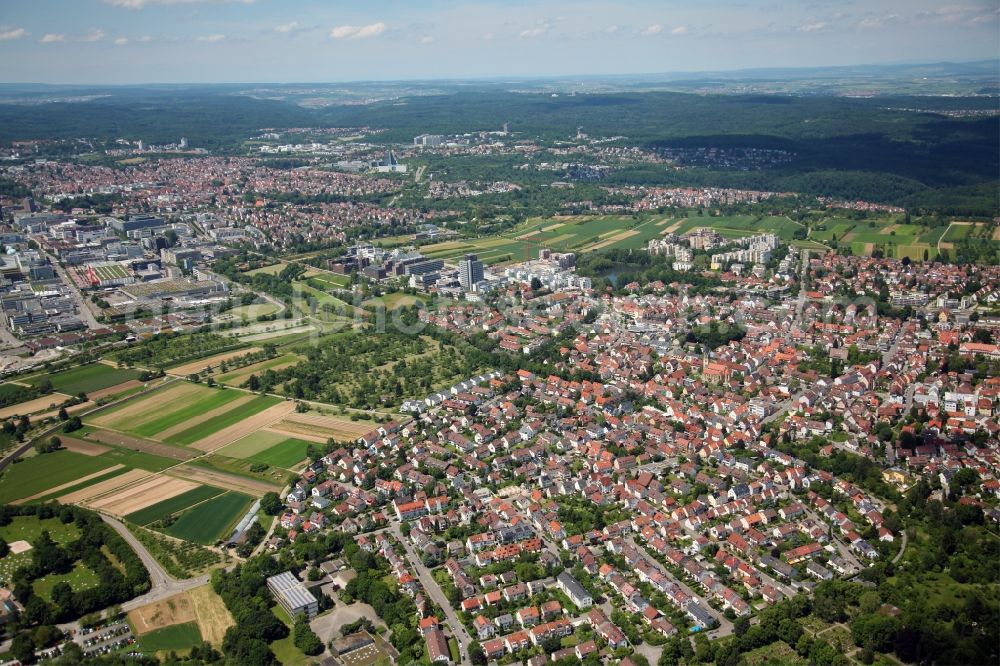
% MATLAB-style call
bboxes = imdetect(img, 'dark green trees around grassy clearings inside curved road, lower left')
[0,504,150,628]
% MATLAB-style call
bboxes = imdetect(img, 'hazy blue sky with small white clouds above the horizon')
[0,0,1000,84]
